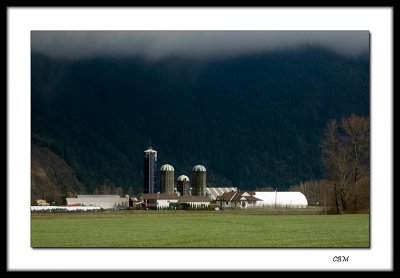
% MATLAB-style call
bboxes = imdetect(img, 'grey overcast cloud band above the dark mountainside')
[31,31,369,60]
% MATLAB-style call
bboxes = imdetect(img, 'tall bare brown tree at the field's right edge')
[321,114,369,212]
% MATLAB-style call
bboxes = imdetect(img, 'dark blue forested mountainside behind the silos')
[32,48,369,200]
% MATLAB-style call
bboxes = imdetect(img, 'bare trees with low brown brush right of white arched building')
[289,114,370,213]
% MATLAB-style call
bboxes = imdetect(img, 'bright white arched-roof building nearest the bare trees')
[254,191,308,208]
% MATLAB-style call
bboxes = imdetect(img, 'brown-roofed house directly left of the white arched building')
[217,191,262,209]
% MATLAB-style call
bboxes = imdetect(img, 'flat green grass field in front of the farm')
[31,210,369,248]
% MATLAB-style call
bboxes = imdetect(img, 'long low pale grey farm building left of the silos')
[66,195,129,209]
